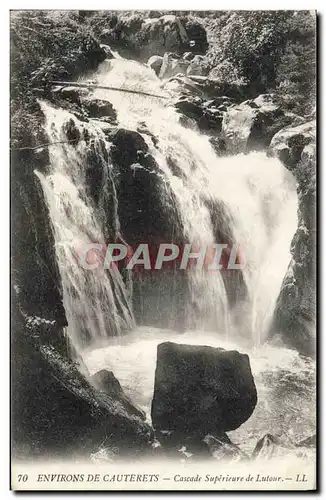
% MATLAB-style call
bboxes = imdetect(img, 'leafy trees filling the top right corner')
[201,11,316,111]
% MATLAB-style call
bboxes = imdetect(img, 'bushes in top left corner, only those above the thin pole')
[11,11,103,97]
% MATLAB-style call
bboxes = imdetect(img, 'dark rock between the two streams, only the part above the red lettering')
[110,129,182,245]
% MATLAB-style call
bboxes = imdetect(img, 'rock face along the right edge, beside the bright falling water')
[269,122,316,355]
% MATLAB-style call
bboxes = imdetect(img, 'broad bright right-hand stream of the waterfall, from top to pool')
[89,59,297,343]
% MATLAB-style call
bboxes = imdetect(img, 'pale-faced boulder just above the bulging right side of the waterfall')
[222,95,293,154]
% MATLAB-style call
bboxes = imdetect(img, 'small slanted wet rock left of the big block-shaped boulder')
[91,370,146,420]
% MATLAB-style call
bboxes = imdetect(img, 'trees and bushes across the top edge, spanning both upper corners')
[11,10,316,148]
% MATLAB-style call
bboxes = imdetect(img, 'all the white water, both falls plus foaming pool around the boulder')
[37,58,315,458]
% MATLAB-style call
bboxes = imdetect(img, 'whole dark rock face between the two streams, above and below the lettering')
[110,129,185,327]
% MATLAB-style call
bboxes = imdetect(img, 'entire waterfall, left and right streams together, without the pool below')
[37,58,297,350]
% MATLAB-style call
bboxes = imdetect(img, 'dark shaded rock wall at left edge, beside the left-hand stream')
[11,134,67,324]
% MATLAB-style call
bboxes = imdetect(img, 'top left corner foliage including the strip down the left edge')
[10,10,105,144]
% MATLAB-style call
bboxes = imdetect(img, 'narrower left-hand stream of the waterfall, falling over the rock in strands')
[35,103,134,349]
